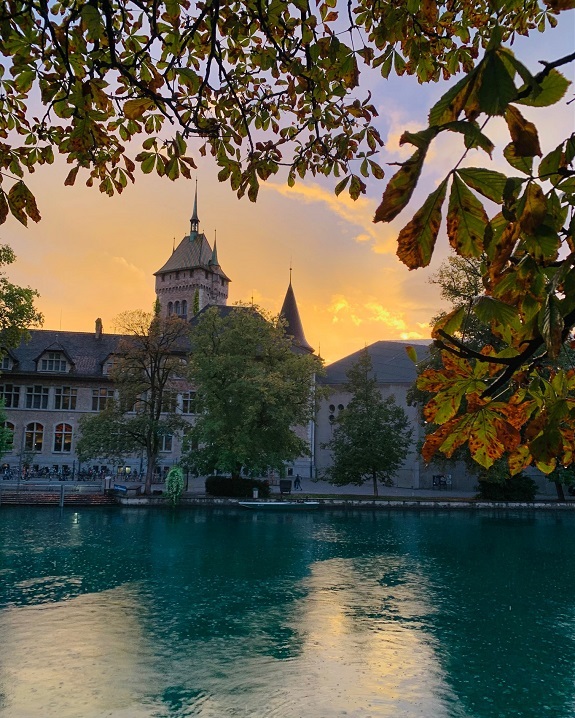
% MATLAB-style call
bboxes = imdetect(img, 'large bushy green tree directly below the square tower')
[188,305,321,477]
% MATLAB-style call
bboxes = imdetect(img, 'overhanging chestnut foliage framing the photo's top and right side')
[0,0,575,473]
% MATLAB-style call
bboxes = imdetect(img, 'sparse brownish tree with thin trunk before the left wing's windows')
[77,311,189,494]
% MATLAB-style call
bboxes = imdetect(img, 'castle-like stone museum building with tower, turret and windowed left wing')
[0,192,320,478]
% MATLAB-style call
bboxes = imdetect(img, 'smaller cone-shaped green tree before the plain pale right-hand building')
[325,349,413,496]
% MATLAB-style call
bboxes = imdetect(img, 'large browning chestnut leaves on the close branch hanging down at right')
[375,23,575,473]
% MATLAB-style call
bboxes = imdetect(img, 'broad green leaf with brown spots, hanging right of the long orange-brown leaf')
[447,174,489,257]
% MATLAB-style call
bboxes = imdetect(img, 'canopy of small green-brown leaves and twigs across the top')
[0,0,570,224]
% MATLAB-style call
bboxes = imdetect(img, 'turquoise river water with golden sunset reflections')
[0,507,575,718]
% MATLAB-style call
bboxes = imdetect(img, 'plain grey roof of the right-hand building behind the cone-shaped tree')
[321,341,429,384]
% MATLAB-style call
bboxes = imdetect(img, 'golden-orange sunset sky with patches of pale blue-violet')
[4,12,575,363]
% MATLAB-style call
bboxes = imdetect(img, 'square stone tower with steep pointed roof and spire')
[154,186,230,319]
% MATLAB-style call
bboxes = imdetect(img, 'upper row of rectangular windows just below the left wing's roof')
[0,384,196,414]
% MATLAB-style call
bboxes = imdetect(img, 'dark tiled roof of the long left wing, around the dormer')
[2,329,122,381]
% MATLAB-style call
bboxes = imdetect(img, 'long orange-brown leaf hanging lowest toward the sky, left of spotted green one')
[397,180,447,269]
